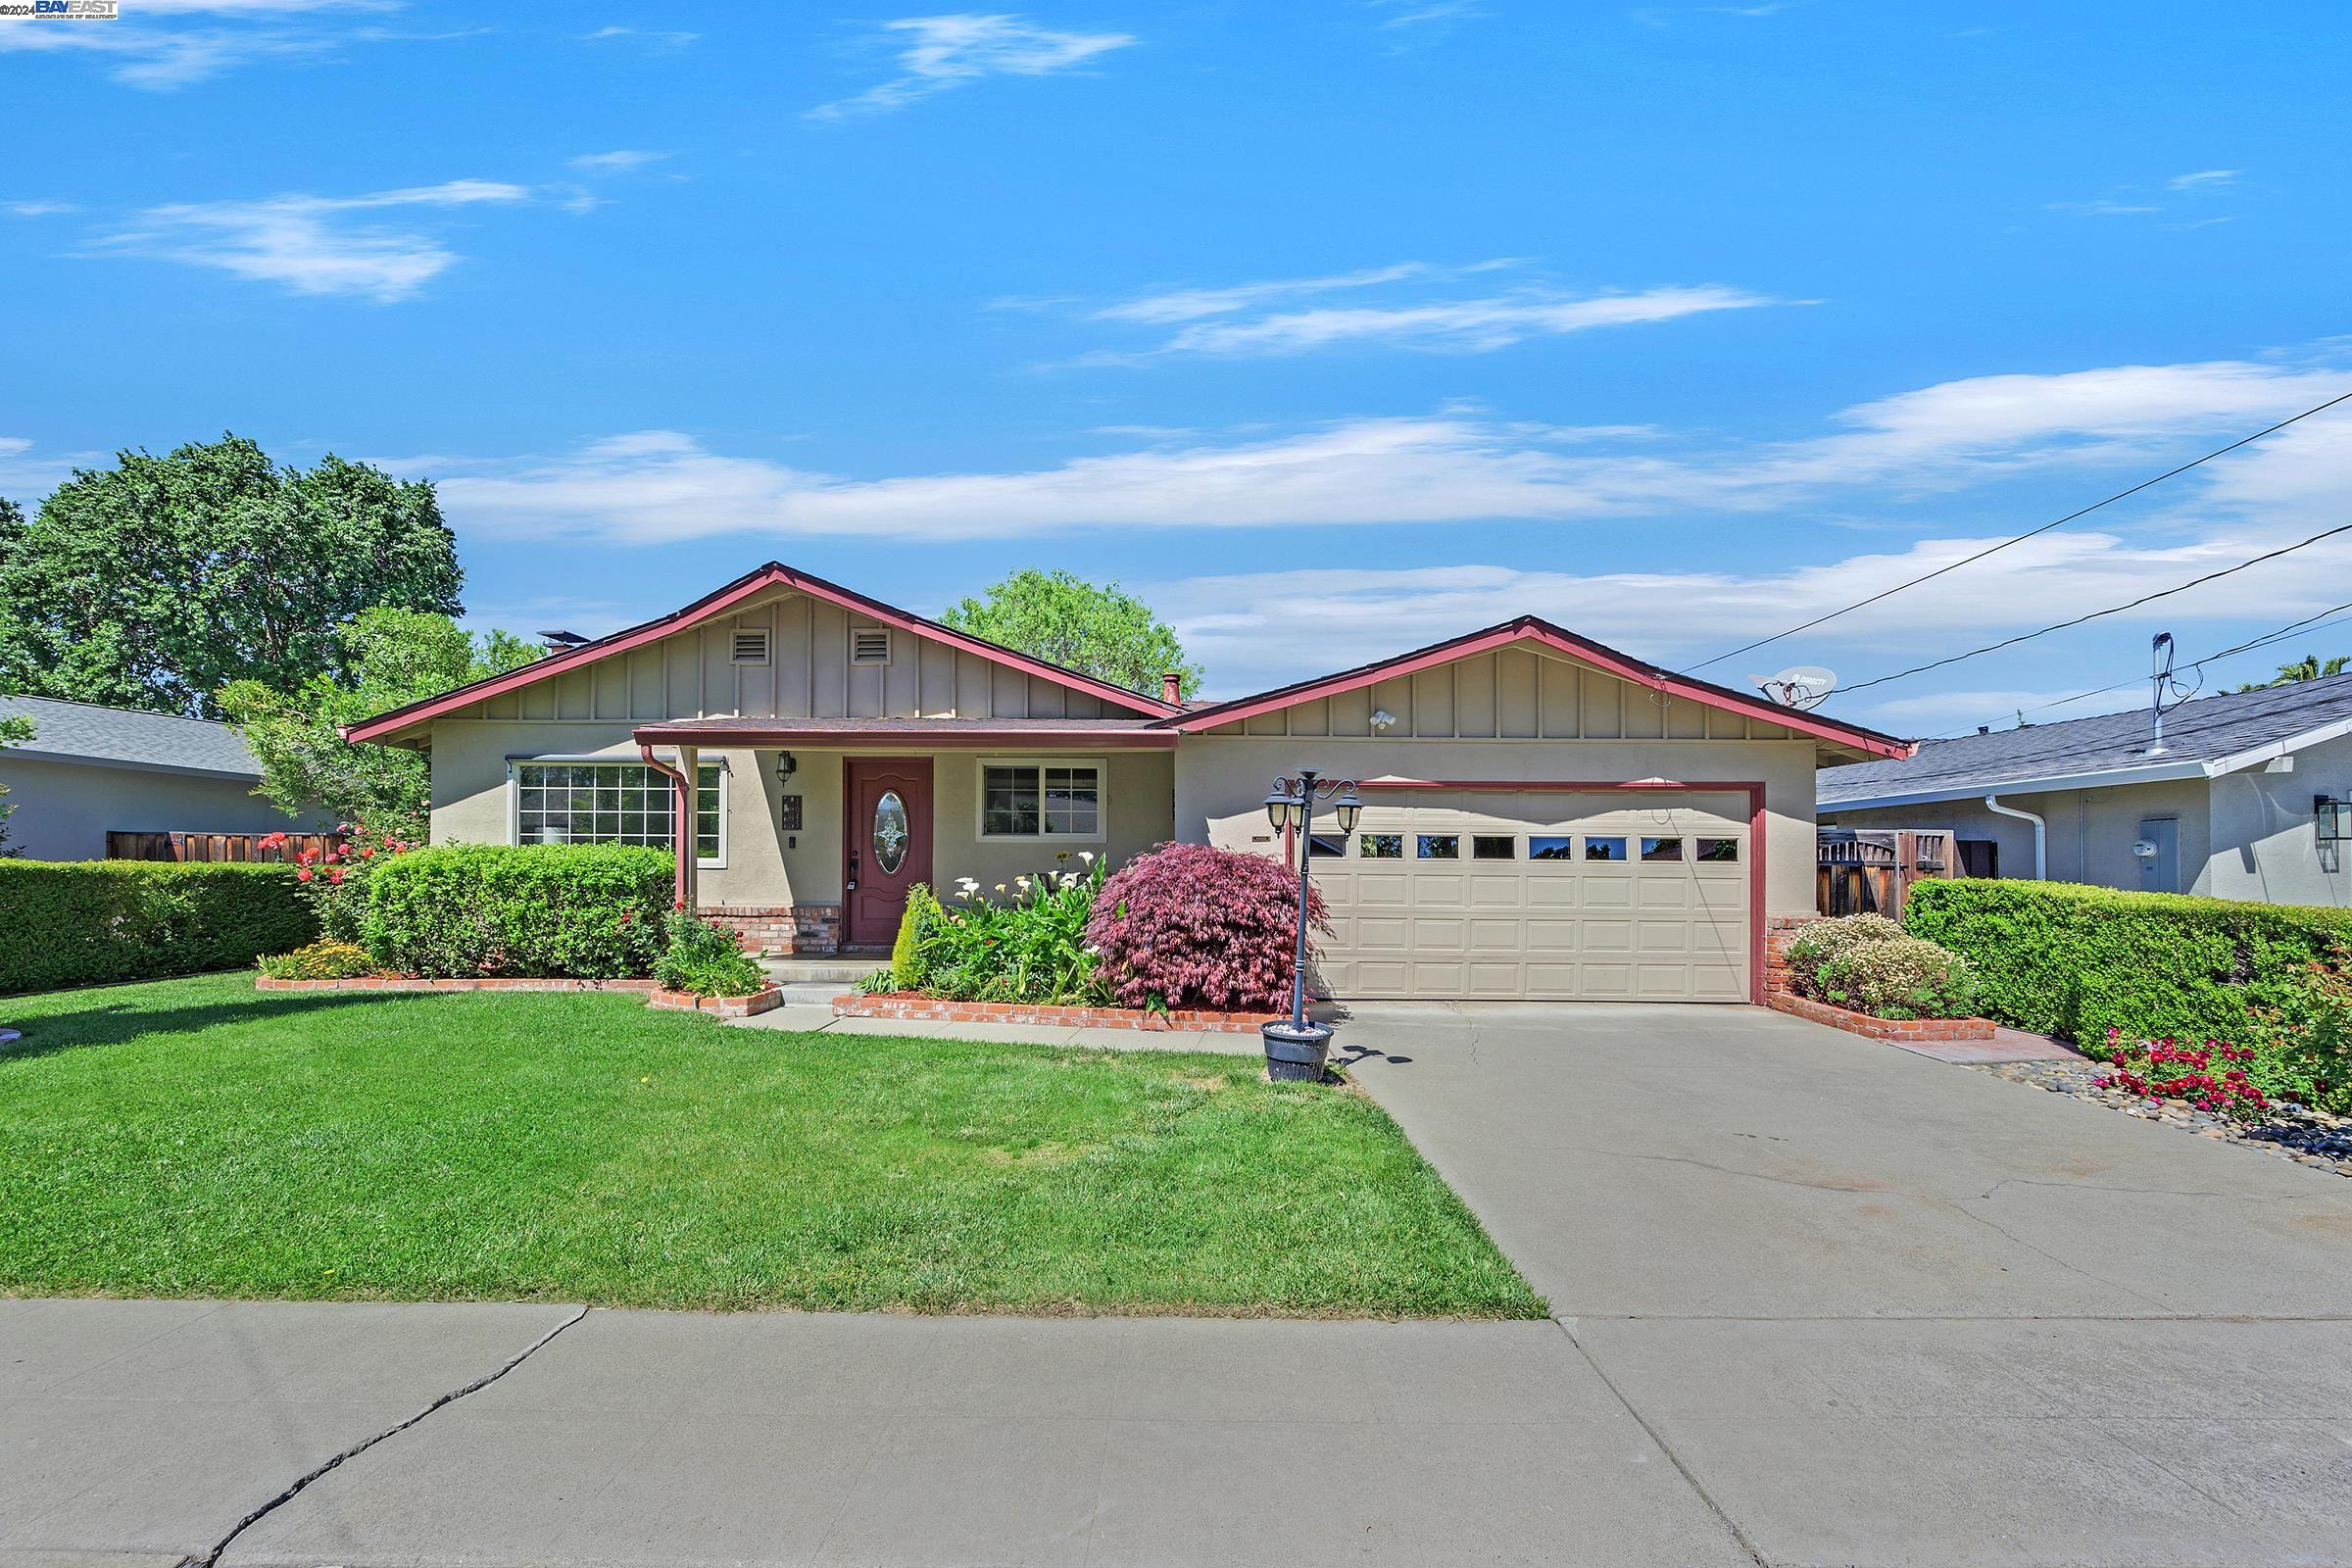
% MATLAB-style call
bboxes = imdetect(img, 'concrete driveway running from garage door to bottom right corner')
[1343,1006,2352,1563]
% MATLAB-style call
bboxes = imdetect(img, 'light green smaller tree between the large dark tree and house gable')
[219,607,546,839]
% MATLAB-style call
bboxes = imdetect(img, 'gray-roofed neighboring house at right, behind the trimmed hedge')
[1818,674,2352,906]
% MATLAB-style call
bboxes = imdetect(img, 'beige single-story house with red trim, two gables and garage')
[346,564,1910,1002]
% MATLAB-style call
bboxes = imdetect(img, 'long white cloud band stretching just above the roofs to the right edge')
[402,362,2352,541]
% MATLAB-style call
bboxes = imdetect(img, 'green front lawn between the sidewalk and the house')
[0,976,1543,1316]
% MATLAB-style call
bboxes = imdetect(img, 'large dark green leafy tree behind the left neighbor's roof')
[0,435,464,717]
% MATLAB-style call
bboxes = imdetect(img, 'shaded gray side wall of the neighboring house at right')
[1821,778,2211,898]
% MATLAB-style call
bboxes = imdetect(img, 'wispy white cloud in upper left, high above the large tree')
[99,178,531,303]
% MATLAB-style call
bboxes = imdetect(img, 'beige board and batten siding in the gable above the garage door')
[1206,649,1797,741]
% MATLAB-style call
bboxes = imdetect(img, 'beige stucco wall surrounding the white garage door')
[1176,733,1813,914]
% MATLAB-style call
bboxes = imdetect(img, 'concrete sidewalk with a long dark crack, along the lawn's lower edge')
[0,1302,1752,1568]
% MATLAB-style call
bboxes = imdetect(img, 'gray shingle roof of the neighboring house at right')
[1813,674,2352,811]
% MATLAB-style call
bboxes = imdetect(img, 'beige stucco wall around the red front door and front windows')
[433,719,1176,906]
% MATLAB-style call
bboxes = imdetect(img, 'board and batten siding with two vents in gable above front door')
[464,592,1124,724]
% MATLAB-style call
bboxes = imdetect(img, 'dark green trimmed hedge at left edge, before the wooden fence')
[0,860,318,992]
